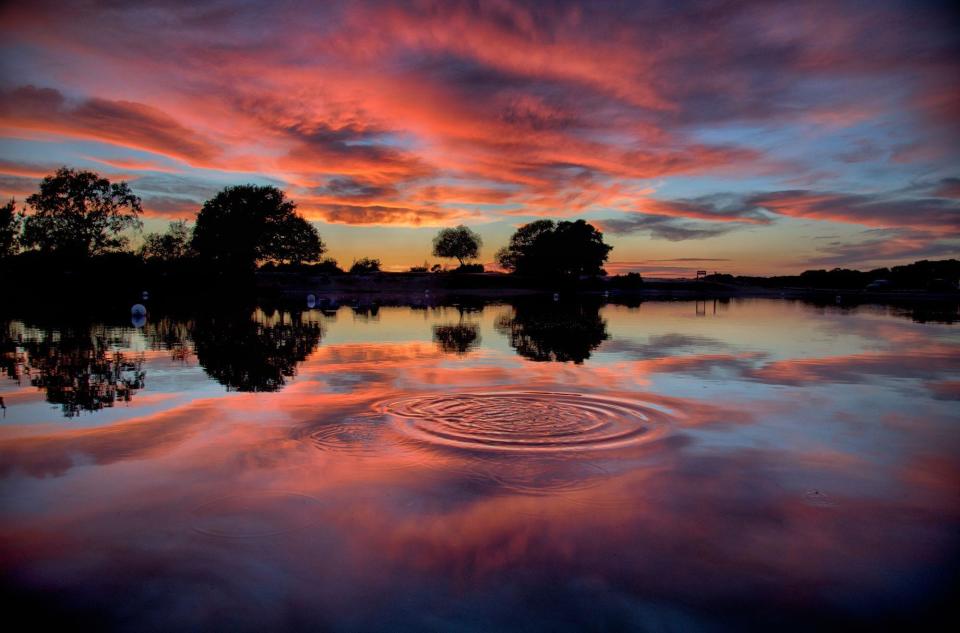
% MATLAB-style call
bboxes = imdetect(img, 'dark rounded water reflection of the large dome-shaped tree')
[192,313,323,391]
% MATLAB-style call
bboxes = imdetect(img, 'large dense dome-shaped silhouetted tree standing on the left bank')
[192,185,325,272]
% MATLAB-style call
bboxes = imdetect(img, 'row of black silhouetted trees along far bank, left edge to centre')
[0,167,612,296]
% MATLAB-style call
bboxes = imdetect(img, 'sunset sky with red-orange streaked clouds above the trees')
[0,0,960,276]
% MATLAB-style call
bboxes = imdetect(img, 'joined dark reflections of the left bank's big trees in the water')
[0,310,322,418]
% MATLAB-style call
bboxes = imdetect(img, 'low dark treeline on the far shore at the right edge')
[706,259,960,291]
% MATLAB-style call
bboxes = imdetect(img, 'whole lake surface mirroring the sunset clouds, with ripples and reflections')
[0,300,960,631]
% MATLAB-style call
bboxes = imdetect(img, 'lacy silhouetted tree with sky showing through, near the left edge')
[22,167,142,257]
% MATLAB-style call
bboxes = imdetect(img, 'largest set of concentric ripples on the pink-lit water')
[379,392,673,452]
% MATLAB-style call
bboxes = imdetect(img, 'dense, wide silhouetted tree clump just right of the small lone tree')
[497,220,613,277]
